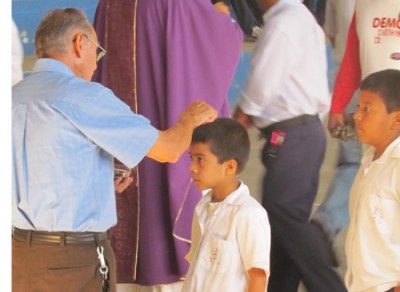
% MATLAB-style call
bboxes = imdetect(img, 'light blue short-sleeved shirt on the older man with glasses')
[12,59,158,232]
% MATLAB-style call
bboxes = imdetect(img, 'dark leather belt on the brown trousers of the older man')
[13,227,109,245]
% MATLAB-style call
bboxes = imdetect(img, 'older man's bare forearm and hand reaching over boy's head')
[146,101,217,162]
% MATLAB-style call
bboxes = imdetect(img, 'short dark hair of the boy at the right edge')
[360,69,400,113]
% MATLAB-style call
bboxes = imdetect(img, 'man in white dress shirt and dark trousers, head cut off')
[235,0,346,292]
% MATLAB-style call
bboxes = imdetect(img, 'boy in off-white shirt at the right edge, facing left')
[345,69,400,292]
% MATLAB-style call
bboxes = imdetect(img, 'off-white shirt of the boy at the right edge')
[345,137,400,292]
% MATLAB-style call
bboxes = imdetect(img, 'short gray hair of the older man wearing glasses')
[35,8,93,58]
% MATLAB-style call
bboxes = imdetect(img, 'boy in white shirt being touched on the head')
[183,118,270,292]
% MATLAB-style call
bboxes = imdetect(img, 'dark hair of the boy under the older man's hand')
[192,118,250,173]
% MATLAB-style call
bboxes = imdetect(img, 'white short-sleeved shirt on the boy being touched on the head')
[182,183,271,292]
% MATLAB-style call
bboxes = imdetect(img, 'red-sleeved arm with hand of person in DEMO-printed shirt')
[328,13,361,130]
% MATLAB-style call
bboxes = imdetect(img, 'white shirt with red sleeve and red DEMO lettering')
[330,0,400,113]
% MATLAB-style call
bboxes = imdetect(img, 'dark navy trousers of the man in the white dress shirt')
[262,119,346,292]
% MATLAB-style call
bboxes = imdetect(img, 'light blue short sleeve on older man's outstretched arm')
[50,85,158,167]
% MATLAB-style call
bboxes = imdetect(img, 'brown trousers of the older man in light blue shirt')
[12,232,117,292]
